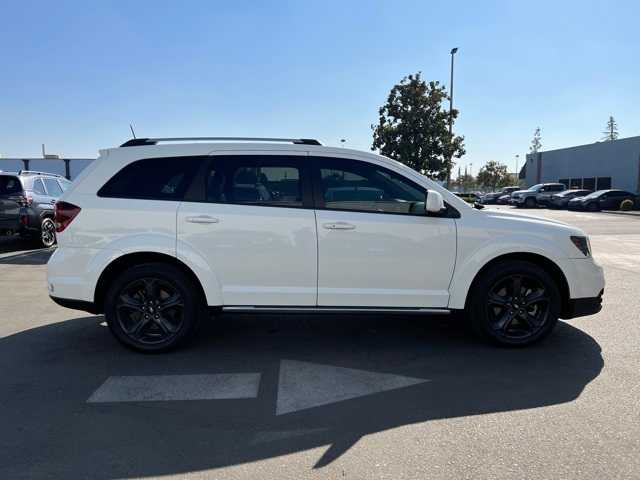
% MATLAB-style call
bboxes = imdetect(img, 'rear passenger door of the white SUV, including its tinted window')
[177,151,317,306]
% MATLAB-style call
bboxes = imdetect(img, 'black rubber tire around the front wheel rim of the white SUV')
[469,260,561,347]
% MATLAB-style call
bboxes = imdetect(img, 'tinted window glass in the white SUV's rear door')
[206,156,302,207]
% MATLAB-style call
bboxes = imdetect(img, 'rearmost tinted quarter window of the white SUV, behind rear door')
[98,157,203,201]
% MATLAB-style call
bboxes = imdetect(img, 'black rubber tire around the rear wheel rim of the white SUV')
[104,263,204,353]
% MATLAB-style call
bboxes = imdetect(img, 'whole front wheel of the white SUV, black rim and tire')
[467,260,561,347]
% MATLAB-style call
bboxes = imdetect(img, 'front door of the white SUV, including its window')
[314,157,456,308]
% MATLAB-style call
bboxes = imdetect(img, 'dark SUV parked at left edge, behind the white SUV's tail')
[0,170,71,247]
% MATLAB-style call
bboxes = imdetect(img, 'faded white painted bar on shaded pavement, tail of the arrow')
[87,373,260,403]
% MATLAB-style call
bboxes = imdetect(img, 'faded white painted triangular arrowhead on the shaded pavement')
[276,360,429,415]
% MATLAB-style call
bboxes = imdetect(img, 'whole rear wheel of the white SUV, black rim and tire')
[104,263,206,353]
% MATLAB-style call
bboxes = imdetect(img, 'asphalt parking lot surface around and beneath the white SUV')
[0,207,640,479]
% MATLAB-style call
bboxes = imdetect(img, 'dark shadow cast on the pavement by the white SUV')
[0,316,603,479]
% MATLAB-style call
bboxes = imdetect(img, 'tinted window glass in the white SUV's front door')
[319,159,425,215]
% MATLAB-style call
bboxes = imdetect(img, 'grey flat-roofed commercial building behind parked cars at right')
[520,136,640,193]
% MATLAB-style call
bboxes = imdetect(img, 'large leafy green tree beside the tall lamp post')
[371,72,465,180]
